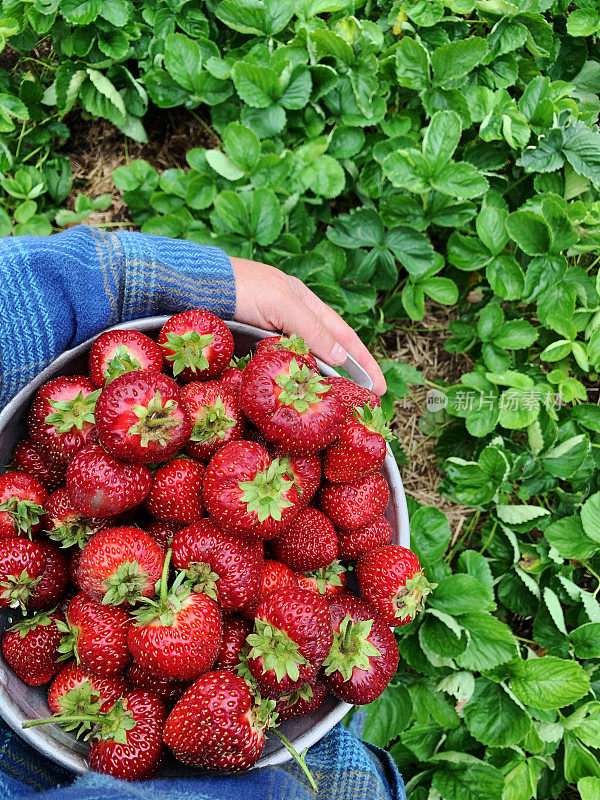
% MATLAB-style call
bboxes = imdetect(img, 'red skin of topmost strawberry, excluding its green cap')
[158,309,234,383]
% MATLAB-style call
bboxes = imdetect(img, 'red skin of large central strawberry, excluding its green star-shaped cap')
[202,441,300,540]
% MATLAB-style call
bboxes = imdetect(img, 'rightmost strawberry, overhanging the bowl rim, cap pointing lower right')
[356,544,437,625]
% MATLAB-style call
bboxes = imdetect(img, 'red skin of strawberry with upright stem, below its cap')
[127,593,223,681]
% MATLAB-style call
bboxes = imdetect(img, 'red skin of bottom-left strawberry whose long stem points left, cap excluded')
[89,689,167,781]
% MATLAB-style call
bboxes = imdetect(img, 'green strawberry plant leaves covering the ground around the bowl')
[0,0,600,800]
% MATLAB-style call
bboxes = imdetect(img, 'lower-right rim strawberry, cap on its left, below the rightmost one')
[322,593,399,705]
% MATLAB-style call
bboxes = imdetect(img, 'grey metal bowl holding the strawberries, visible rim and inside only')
[0,317,410,777]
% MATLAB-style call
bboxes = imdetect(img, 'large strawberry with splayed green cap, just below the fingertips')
[240,350,345,453]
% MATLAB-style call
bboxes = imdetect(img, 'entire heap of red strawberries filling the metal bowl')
[0,311,431,780]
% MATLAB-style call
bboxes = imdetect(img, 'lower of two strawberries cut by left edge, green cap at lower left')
[0,538,46,611]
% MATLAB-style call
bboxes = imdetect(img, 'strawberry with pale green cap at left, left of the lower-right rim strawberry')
[248,587,333,692]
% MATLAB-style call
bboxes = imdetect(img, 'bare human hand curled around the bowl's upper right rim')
[231,258,386,394]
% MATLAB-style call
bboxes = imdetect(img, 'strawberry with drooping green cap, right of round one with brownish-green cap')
[181,381,244,461]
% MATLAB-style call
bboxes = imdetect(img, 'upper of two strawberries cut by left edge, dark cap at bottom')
[0,472,48,539]
